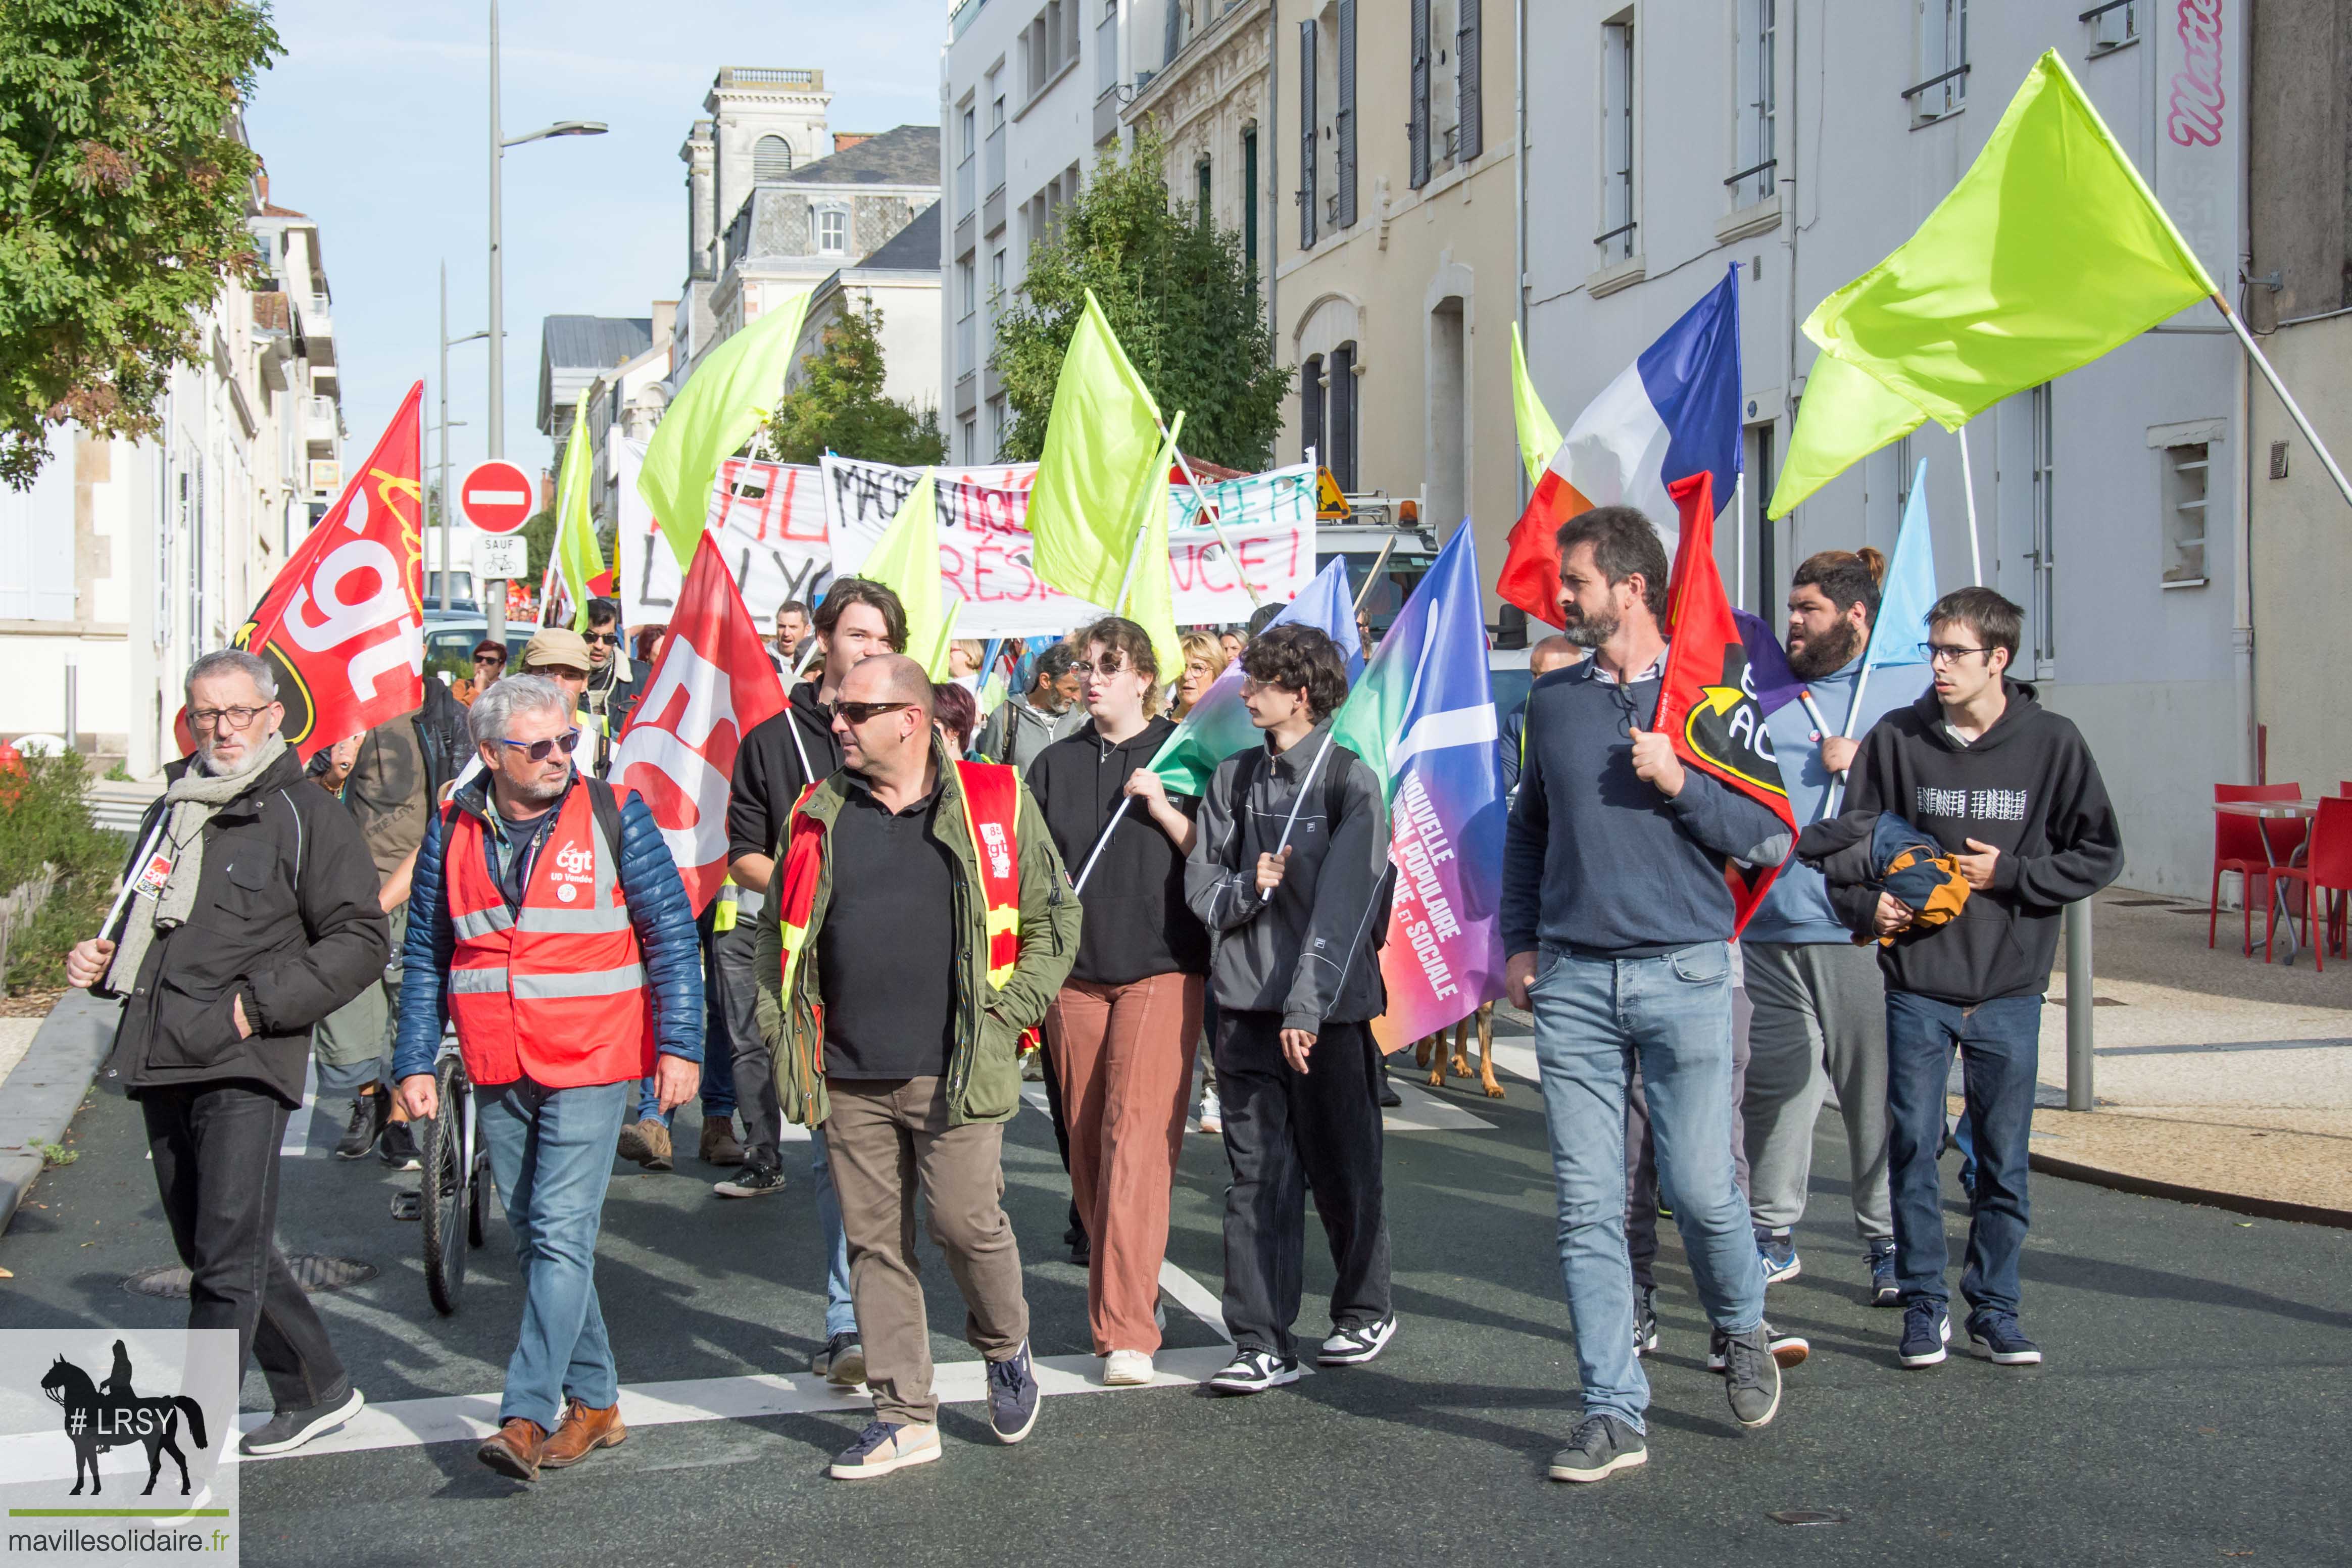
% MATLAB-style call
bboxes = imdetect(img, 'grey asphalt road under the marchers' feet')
[0,1030,2352,1568]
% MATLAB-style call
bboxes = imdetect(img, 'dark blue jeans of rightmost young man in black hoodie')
[1886,990,2041,1312]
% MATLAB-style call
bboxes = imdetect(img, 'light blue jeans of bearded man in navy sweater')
[1529,943,1764,1432]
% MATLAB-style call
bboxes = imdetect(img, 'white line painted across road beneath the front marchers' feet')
[237,1345,1233,1464]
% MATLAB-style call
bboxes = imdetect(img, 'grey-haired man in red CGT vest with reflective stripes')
[393,675,703,1481]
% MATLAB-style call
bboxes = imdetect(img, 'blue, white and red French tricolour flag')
[1496,263,1740,625]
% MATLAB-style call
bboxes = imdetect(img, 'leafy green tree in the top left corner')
[0,0,282,489]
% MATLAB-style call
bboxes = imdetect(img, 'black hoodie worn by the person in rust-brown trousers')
[1028,717,1209,985]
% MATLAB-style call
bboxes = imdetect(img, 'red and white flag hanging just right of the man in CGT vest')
[612,533,783,914]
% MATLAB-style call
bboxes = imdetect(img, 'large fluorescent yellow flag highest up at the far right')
[1804,50,2213,432]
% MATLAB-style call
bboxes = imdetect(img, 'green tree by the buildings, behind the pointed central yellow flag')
[997,127,1291,470]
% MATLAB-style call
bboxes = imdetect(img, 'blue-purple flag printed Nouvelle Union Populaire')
[1331,519,1503,1051]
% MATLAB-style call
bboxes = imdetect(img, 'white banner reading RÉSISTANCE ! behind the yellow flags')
[823,456,1315,637]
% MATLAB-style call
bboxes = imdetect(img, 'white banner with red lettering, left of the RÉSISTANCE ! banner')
[612,435,832,625]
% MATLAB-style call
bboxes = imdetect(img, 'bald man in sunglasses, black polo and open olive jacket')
[757,654,1077,1481]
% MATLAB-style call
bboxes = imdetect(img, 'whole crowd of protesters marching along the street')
[68,508,2122,1481]
